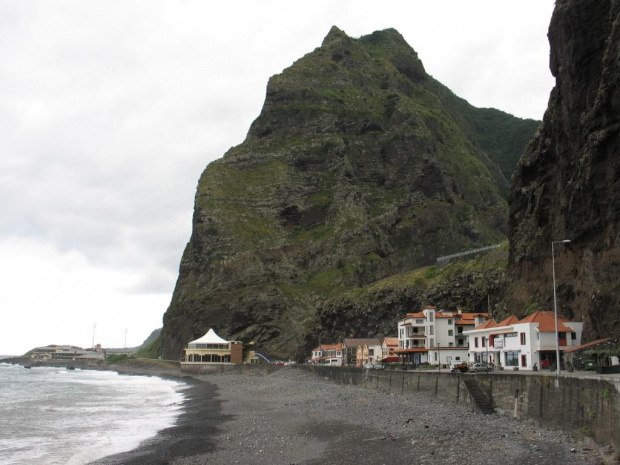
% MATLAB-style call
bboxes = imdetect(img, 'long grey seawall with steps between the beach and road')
[299,365,620,450]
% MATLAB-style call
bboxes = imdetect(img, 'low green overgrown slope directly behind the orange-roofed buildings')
[297,242,508,360]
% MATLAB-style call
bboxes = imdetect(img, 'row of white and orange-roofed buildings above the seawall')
[311,305,620,371]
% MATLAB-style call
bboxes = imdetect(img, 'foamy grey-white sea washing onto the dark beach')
[0,361,188,465]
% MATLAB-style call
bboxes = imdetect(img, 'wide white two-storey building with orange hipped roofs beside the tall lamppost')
[466,311,583,370]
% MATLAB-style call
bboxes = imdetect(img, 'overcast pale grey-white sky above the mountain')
[0,0,554,355]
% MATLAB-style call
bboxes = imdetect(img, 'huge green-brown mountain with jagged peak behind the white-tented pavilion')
[161,27,539,357]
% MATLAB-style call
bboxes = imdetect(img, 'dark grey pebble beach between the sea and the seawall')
[1,358,615,465]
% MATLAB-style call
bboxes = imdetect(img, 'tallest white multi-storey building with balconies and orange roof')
[394,305,488,365]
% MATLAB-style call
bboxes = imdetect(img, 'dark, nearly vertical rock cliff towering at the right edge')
[509,0,620,339]
